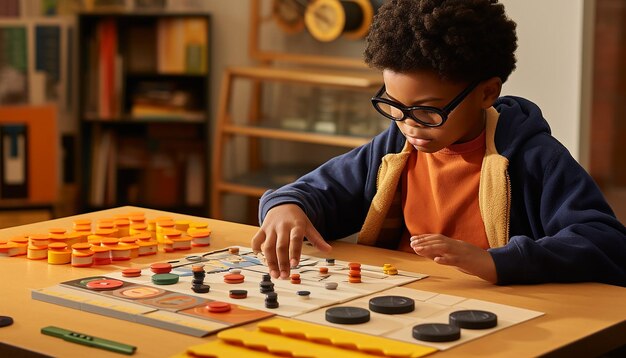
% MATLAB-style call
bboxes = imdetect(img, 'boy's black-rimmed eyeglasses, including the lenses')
[371,81,480,127]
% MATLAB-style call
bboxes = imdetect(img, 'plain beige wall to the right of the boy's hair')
[501,0,593,164]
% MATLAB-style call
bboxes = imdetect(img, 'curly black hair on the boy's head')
[365,0,517,82]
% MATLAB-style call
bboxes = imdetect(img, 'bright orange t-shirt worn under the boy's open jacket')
[398,131,489,252]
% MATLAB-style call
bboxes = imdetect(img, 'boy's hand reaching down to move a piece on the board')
[252,204,332,278]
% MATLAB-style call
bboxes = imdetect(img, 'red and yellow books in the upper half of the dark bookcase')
[85,17,208,120]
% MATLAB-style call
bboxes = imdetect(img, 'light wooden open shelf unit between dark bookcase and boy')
[211,66,383,219]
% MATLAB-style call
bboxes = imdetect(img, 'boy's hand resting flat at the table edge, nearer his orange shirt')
[411,234,498,283]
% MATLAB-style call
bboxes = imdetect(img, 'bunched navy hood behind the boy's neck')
[493,96,551,158]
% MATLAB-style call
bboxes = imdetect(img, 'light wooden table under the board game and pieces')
[0,206,626,358]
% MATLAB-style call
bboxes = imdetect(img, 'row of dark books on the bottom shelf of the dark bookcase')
[89,129,206,207]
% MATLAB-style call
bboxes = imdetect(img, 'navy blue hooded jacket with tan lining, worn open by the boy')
[259,96,626,286]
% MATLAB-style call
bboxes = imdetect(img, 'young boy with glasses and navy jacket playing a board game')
[252,0,626,286]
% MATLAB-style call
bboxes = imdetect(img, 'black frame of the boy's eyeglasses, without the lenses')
[370,81,480,128]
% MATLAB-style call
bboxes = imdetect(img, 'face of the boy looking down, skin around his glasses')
[383,70,485,153]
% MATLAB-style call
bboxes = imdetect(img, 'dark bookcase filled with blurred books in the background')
[78,12,211,216]
